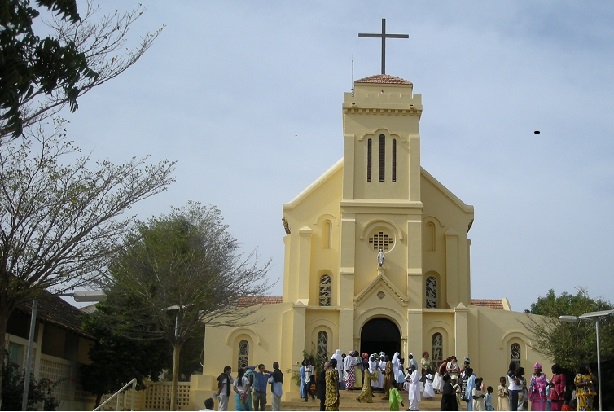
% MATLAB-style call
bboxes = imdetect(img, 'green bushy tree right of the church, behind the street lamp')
[525,289,614,371]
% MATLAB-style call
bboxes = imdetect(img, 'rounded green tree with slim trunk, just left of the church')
[104,202,270,410]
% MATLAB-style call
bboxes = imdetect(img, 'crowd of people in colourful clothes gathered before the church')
[205,349,597,411]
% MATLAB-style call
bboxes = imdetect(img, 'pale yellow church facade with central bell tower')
[197,74,550,404]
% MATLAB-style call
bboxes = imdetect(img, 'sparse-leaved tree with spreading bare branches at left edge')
[0,122,174,406]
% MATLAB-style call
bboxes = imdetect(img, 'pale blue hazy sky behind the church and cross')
[61,0,614,311]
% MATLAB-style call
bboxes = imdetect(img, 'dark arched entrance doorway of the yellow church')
[360,318,401,360]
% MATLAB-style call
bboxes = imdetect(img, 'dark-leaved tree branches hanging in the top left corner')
[0,0,161,140]
